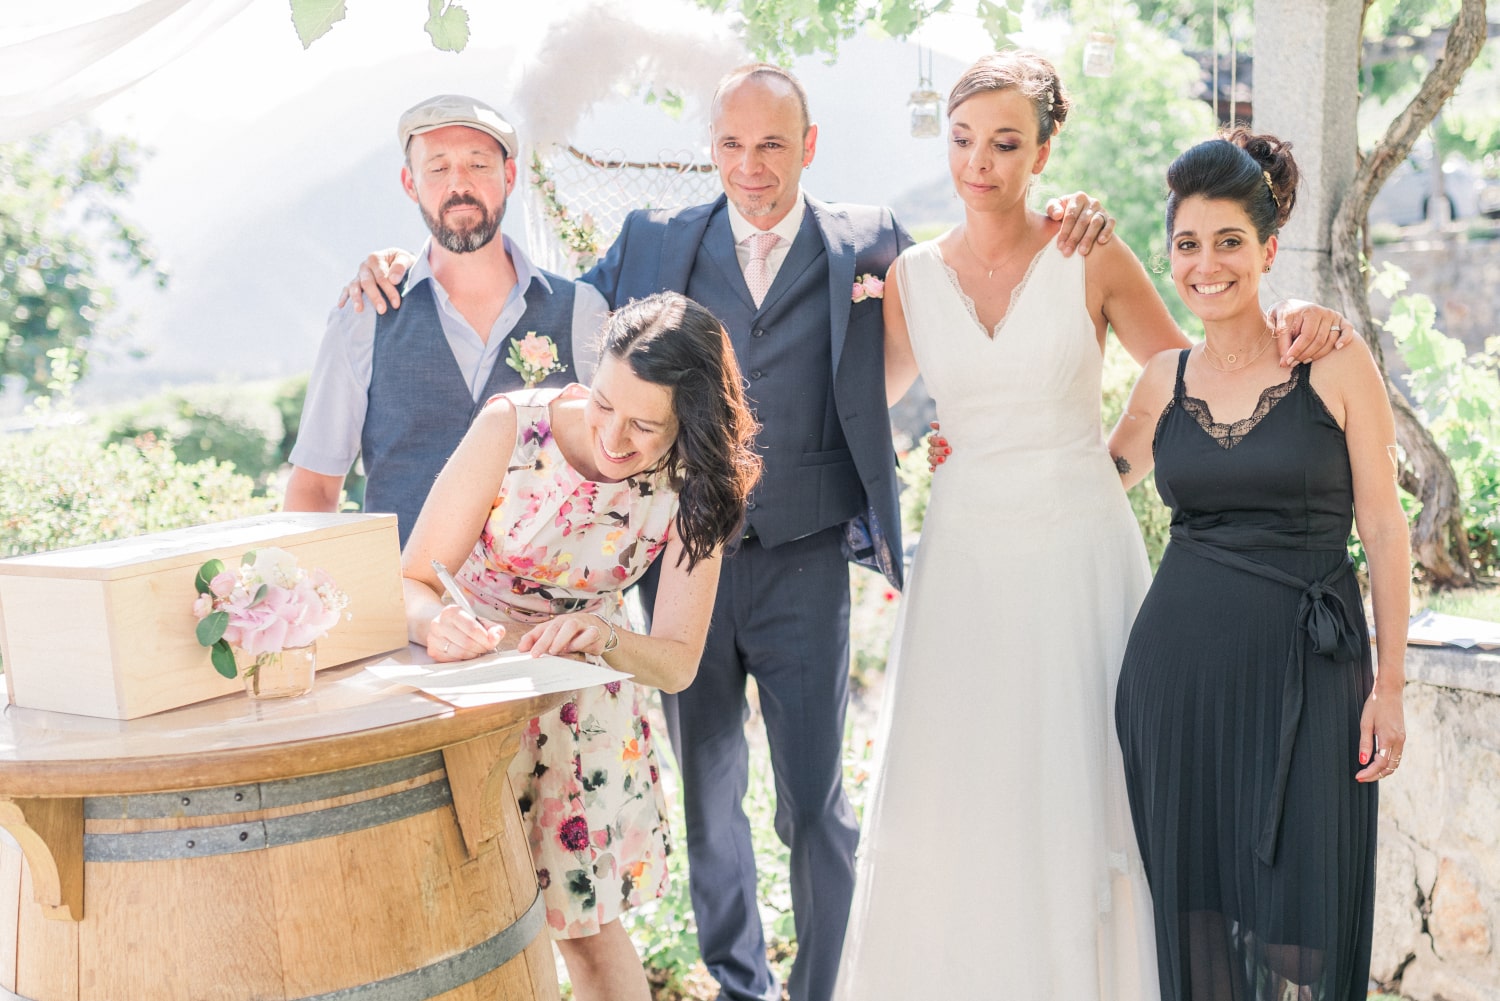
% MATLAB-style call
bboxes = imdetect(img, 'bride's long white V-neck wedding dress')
[836,243,1158,1001]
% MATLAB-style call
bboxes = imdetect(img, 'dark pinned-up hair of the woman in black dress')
[1167,126,1299,243]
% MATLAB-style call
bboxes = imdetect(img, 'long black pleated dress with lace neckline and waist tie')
[1115,351,1377,1001]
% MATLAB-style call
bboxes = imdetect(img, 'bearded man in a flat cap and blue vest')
[285,95,608,545]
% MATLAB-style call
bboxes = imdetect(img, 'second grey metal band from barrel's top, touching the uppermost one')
[84,779,453,864]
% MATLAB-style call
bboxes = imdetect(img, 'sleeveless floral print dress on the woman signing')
[458,386,677,938]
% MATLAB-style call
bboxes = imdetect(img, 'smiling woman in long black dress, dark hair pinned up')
[1110,129,1410,1001]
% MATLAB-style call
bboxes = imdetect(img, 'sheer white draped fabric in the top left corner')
[0,0,252,143]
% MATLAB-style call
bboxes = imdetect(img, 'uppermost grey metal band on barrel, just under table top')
[84,750,443,822]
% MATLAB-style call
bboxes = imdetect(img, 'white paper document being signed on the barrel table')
[365,645,630,708]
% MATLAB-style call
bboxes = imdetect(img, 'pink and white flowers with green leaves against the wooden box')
[192,548,350,678]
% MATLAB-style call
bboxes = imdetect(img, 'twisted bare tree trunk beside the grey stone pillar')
[1329,0,1488,587]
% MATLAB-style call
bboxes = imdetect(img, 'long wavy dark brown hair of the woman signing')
[600,293,761,570]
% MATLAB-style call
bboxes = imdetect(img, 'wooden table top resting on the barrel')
[0,662,569,797]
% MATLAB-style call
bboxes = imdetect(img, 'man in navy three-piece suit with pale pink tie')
[584,63,1106,1001]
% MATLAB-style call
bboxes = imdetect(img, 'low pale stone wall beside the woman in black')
[1371,647,1500,1001]
